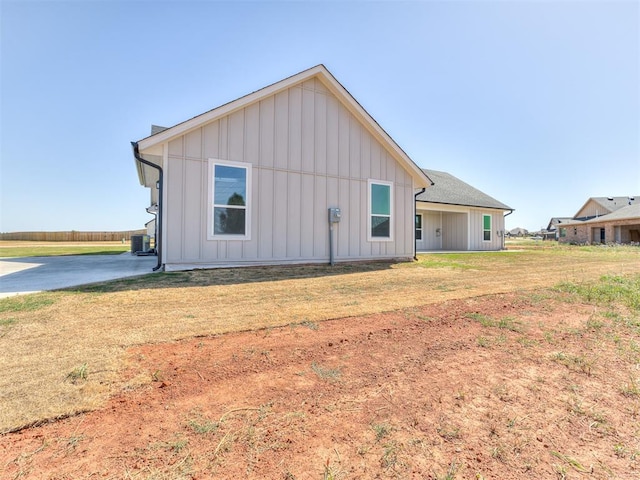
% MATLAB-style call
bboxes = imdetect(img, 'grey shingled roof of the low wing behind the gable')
[416,170,513,210]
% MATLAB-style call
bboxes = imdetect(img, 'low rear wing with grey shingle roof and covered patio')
[416,170,513,251]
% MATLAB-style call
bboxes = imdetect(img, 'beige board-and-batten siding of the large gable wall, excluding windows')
[158,78,414,270]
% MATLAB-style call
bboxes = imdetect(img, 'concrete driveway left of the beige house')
[0,253,158,298]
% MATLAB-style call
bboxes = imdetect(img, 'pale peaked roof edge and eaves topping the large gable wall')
[138,65,432,187]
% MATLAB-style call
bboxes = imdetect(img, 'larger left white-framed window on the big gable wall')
[210,162,251,240]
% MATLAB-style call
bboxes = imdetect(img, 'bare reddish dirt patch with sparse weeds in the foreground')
[0,291,640,480]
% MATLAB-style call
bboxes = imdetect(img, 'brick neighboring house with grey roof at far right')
[558,195,640,244]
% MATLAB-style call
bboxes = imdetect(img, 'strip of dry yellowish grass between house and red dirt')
[0,247,640,432]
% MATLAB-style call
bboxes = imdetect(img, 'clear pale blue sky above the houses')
[0,0,640,232]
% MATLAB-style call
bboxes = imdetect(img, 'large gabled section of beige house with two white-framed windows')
[132,65,436,270]
